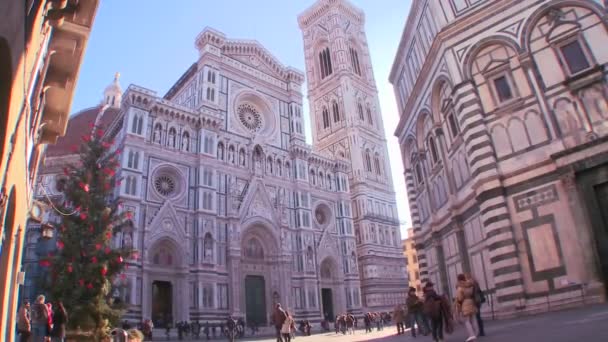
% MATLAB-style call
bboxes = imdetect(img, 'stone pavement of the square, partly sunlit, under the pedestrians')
[155,304,608,342]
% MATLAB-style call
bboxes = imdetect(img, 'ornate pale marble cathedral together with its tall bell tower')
[32,0,407,326]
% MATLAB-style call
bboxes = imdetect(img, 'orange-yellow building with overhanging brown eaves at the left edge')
[0,0,99,341]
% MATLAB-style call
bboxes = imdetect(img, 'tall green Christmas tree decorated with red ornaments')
[40,125,132,339]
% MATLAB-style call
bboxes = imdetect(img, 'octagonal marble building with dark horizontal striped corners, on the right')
[390,0,608,316]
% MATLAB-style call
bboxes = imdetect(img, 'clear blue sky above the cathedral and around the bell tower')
[72,0,411,237]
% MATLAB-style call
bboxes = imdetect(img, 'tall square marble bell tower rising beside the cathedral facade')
[298,0,407,310]
